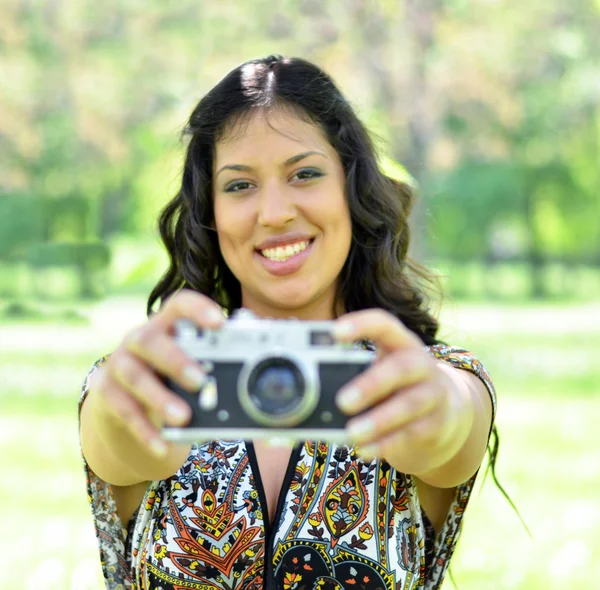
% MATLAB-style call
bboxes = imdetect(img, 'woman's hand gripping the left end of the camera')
[88,290,225,457]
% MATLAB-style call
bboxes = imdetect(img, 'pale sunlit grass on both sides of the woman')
[0,299,600,590]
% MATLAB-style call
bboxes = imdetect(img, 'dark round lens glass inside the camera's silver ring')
[248,358,306,421]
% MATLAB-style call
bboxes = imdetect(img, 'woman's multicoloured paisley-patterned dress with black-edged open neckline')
[79,345,496,590]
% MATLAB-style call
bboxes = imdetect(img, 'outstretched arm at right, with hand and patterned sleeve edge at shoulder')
[336,309,493,488]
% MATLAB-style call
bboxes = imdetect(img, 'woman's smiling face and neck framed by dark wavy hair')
[213,110,352,319]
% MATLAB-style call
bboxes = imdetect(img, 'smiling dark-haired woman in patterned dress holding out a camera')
[80,56,495,590]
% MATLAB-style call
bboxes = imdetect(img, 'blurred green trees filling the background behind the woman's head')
[0,0,600,294]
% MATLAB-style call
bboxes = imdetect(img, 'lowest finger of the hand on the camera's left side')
[99,379,168,457]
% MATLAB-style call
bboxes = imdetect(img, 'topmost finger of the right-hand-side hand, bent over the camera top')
[332,309,423,352]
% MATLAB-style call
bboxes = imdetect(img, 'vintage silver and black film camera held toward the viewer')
[163,310,374,443]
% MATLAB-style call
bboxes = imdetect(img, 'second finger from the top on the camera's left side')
[123,324,206,391]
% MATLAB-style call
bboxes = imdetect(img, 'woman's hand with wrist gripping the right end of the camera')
[334,309,473,474]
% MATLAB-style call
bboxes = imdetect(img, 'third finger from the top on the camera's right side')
[346,382,447,445]
